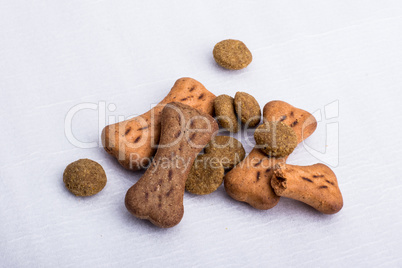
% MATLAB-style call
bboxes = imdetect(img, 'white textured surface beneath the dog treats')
[0,0,402,267]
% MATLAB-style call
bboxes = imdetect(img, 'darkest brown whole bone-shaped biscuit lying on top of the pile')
[125,102,219,228]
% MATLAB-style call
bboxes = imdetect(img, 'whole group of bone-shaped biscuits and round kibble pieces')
[63,40,343,228]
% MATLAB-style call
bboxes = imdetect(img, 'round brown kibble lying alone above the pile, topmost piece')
[213,39,253,70]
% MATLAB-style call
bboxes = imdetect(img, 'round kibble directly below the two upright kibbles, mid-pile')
[205,136,246,169]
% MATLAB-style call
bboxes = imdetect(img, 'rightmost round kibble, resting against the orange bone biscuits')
[254,121,297,157]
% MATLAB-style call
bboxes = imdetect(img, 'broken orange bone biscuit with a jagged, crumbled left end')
[271,164,343,214]
